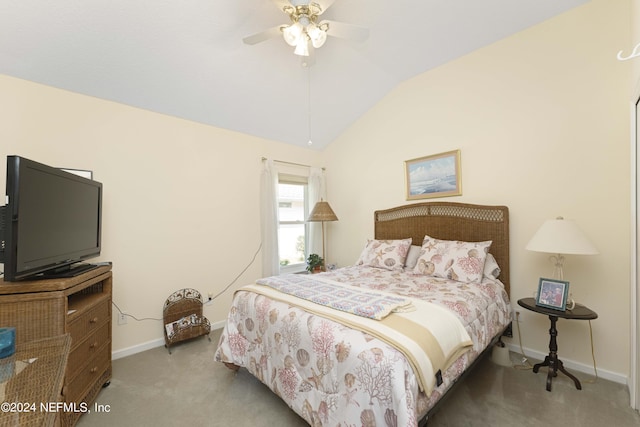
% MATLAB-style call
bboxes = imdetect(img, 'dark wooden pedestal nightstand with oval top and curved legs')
[518,298,598,391]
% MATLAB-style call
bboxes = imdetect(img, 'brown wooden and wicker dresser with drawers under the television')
[0,266,112,426]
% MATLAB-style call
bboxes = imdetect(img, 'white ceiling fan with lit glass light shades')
[242,0,369,66]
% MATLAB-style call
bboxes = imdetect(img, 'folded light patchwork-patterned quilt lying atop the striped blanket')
[257,274,415,320]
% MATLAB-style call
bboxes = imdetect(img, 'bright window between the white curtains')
[278,175,308,273]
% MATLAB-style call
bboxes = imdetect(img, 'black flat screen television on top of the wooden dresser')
[0,156,102,282]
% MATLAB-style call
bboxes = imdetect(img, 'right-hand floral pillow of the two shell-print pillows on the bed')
[413,236,492,283]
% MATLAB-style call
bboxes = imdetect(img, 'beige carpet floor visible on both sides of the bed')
[77,330,640,427]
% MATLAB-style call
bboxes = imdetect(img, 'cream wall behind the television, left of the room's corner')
[0,76,319,352]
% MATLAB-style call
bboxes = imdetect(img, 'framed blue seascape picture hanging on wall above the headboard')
[404,150,462,200]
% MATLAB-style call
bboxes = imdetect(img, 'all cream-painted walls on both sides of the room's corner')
[0,0,631,379]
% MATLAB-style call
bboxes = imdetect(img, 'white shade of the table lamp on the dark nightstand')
[526,217,598,255]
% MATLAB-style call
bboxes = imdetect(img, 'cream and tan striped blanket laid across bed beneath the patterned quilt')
[238,284,473,395]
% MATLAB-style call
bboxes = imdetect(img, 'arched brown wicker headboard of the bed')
[374,202,510,294]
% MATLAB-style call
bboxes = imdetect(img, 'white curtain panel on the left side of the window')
[260,160,280,277]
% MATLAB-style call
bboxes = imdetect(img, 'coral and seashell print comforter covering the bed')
[215,267,511,427]
